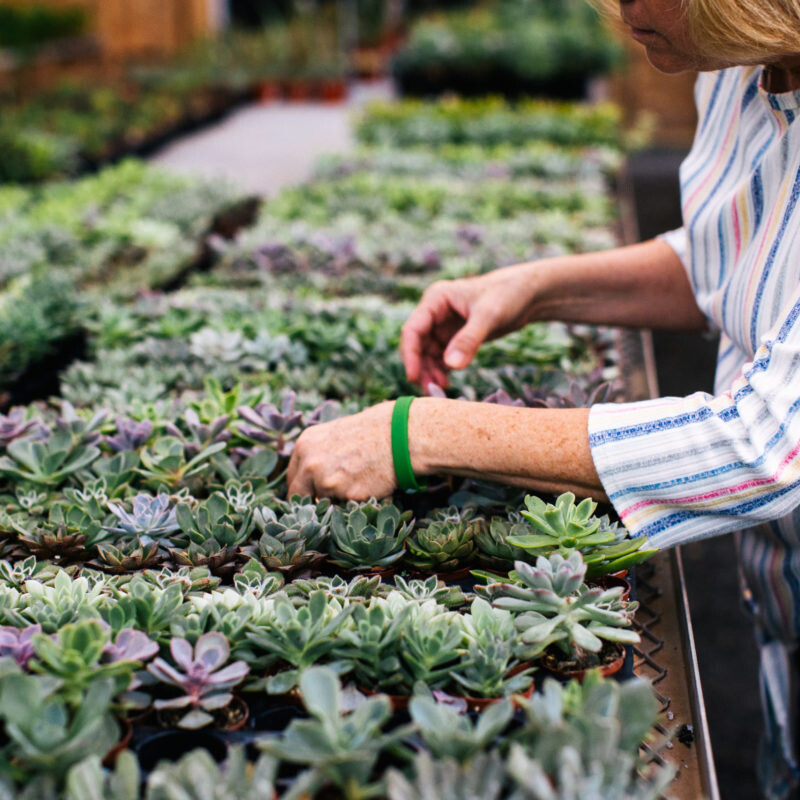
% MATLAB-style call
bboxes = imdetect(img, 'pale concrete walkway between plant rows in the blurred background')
[151,83,391,195]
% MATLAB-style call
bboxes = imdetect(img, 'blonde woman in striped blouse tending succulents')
[289,0,800,798]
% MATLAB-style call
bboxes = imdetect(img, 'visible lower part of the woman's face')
[620,0,730,73]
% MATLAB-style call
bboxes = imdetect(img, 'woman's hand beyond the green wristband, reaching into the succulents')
[287,403,397,500]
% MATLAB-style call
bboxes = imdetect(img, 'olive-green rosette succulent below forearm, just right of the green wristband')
[406,506,486,572]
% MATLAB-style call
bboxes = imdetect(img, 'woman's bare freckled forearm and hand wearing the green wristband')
[288,397,605,500]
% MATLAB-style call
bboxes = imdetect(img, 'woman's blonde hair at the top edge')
[591,0,800,64]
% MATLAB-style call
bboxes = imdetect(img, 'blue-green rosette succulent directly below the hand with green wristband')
[329,503,411,571]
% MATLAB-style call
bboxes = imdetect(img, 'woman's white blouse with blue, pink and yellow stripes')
[589,67,800,547]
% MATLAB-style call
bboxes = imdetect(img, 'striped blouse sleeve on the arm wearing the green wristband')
[589,282,800,547]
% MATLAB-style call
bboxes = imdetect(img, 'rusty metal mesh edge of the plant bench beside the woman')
[619,331,720,800]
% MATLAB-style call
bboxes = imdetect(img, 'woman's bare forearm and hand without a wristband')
[400,239,706,387]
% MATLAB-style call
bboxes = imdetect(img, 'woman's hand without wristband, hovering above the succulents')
[400,264,534,390]
